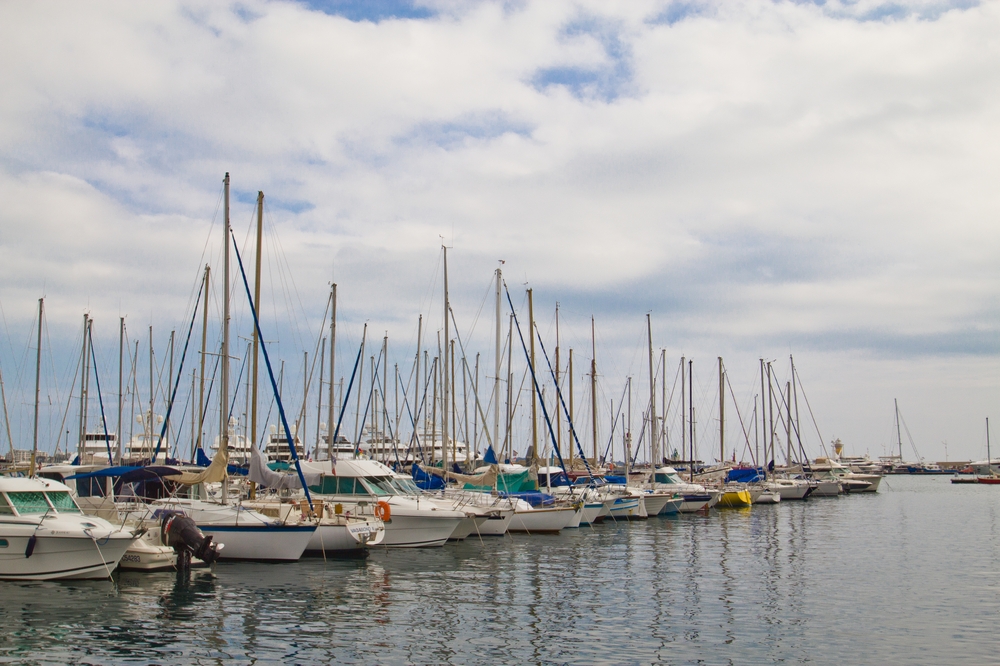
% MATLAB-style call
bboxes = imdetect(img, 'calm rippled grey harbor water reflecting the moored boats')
[0,477,1000,664]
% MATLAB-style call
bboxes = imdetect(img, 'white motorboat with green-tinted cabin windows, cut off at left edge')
[0,477,137,580]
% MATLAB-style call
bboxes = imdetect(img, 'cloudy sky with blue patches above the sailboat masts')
[0,0,1000,460]
